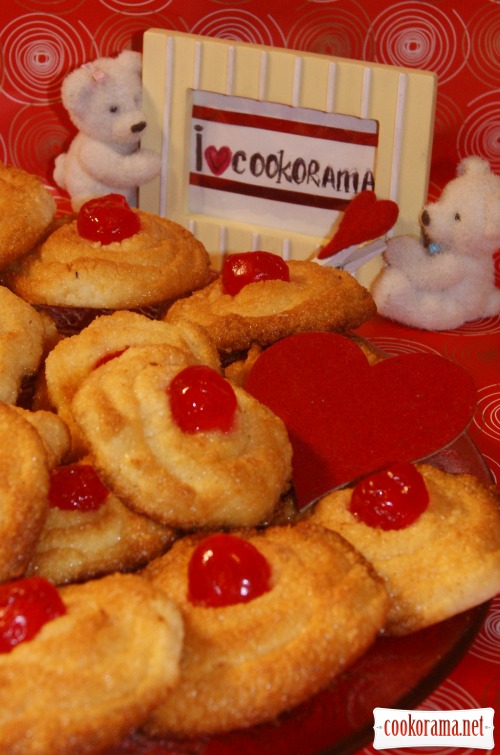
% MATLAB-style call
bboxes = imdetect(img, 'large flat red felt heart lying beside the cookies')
[245,333,476,507]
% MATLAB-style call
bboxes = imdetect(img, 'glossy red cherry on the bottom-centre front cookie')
[188,533,271,608]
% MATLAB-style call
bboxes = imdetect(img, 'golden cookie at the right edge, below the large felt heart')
[311,464,500,635]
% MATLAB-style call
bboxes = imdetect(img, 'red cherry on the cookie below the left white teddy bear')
[76,194,141,244]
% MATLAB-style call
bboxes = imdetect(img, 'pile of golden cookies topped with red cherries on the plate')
[0,162,500,755]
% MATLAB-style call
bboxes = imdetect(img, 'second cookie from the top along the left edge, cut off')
[0,286,58,404]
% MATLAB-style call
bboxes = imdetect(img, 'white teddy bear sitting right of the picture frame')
[372,157,500,330]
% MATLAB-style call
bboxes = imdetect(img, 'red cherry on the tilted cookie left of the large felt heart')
[167,364,237,433]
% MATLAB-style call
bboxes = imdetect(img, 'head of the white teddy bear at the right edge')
[420,157,500,256]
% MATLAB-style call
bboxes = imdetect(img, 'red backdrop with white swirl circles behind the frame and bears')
[0,0,500,204]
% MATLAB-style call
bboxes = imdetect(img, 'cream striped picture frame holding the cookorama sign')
[139,29,436,280]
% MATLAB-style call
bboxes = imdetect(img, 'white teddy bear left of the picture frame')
[54,50,160,211]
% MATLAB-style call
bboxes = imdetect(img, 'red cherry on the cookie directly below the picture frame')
[222,252,290,296]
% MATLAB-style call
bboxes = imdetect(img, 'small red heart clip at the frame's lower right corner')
[318,190,399,259]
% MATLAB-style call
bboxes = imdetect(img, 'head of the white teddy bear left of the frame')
[61,50,147,145]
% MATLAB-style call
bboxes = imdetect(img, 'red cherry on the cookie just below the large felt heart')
[349,462,429,530]
